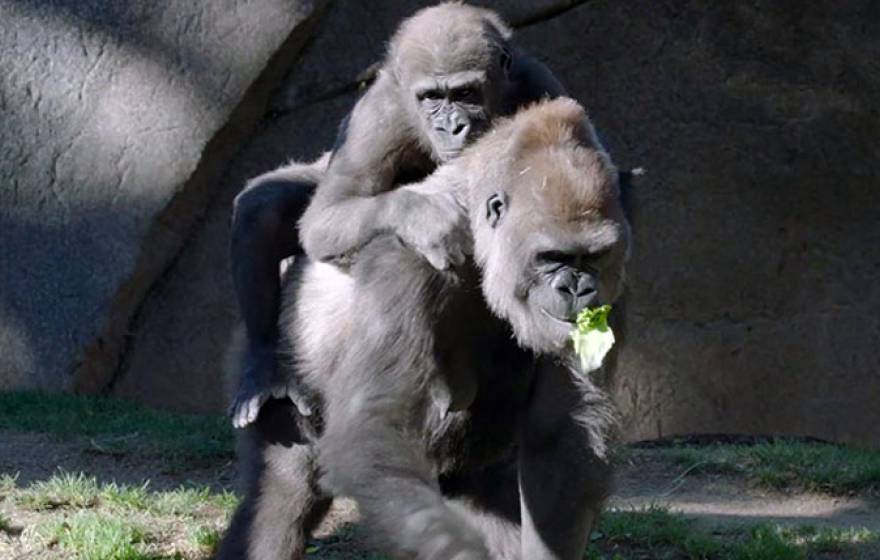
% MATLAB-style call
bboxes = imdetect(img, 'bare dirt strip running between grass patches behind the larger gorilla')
[0,433,880,560]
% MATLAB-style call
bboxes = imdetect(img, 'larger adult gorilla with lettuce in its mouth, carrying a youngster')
[219,99,629,560]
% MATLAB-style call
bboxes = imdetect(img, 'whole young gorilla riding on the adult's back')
[232,3,564,427]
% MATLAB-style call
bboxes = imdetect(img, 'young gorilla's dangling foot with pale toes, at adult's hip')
[229,346,312,428]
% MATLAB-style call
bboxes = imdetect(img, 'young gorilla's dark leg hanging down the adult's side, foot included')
[231,171,317,428]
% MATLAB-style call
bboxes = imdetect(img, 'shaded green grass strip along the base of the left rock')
[0,391,233,460]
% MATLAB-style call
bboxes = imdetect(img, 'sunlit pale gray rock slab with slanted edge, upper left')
[0,0,324,390]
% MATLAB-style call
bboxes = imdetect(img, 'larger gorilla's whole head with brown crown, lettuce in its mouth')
[462,99,630,354]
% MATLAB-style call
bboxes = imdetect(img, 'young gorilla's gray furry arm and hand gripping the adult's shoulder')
[299,73,461,268]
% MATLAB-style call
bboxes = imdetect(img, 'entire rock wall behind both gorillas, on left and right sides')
[0,0,880,446]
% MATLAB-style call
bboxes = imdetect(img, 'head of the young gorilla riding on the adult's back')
[388,2,512,161]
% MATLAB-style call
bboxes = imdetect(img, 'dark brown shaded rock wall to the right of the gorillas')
[520,0,880,446]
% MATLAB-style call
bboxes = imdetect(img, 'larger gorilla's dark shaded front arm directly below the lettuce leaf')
[519,364,614,560]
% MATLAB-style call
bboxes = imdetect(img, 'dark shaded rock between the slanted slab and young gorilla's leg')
[113,95,355,412]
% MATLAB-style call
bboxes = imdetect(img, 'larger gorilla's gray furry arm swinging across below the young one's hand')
[318,236,488,560]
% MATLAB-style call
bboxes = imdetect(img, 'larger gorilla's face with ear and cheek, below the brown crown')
[484,193,629,354]
